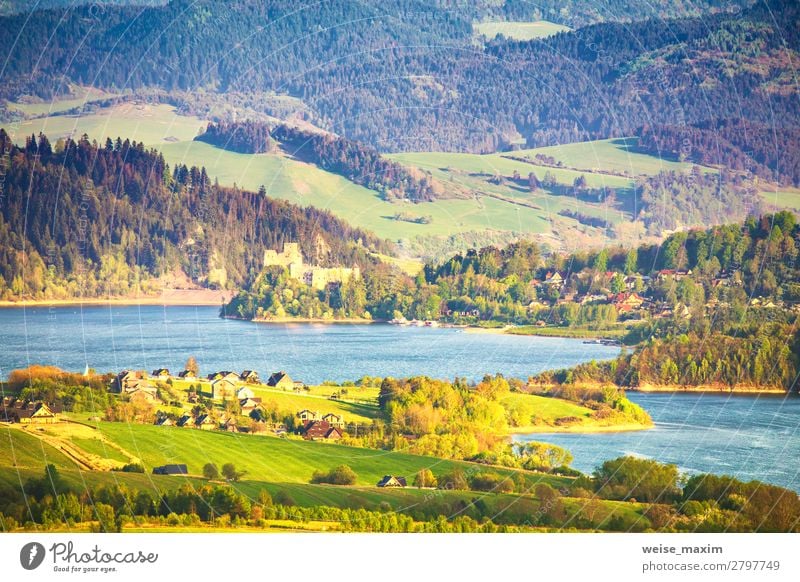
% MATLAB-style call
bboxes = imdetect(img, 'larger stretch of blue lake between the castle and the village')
[0,305,619,384]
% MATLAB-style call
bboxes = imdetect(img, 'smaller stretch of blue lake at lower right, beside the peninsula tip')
[517,392,800,491]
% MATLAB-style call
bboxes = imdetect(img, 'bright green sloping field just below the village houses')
[0,422,568,491]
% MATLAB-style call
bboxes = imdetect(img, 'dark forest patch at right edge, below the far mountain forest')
[638,119,800,186]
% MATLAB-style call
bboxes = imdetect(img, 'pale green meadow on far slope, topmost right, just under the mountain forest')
[512,137,716,180]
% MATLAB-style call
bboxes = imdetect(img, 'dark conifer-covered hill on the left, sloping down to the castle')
[0,129,391,298]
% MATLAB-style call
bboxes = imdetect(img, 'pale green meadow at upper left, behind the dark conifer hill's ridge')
[14,102,206,146]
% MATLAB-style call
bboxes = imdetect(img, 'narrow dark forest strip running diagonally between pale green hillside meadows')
[195,122,436,202]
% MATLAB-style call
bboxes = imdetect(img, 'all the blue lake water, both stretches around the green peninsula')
[0,306,800,490]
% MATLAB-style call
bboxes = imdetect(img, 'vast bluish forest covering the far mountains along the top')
[0,0,800,155]
